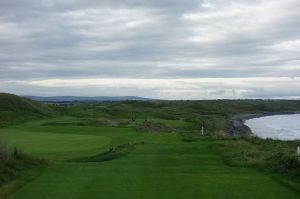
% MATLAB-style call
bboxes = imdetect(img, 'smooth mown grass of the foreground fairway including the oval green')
[0,119,299,199]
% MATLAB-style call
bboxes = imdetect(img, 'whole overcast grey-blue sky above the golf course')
[0,0,300,99]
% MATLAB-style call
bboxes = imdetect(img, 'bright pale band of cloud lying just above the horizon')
[2,77,300,99]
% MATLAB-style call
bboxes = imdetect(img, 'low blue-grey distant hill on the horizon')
[24,96,150,102]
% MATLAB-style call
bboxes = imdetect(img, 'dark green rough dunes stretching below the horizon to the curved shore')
[53,100,300,135]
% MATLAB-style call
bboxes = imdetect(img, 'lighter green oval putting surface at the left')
[0,130,111,157]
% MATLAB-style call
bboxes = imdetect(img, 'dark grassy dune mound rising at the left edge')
[0,93,52,126]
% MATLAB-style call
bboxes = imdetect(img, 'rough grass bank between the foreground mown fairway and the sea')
[212,137,300,193]
